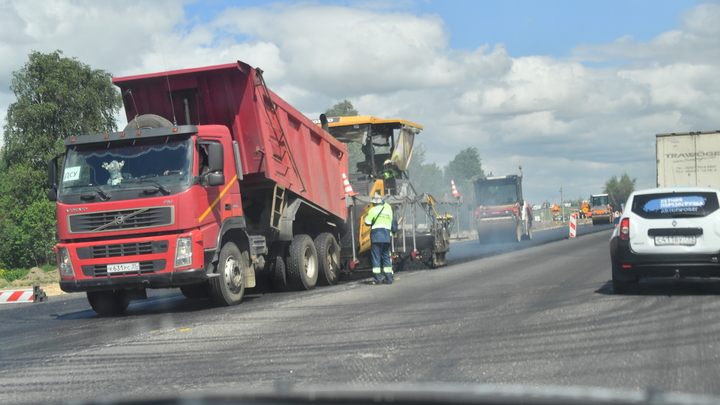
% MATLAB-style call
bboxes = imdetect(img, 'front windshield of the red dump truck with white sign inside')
[59,137,193,200]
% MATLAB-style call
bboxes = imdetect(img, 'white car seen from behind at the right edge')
[610,187,720,294]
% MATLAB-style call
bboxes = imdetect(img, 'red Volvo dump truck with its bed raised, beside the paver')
[48,61,448,315]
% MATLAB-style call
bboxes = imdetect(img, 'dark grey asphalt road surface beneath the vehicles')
[0,223,720,403]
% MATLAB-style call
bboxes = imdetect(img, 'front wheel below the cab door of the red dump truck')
[209,242,249,306]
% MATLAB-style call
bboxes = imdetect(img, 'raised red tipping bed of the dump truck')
[113,61,348,220]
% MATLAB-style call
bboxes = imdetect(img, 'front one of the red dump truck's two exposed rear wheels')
[285,235,318,290]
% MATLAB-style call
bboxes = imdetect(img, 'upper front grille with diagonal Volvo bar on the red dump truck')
[68,206,175,233]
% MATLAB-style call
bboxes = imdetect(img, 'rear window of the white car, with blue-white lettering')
[632,192,718,219]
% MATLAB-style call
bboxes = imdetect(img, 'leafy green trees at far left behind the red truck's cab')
[0,50,122,269]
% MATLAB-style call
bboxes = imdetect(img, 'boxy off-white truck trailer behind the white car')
[655,130,720,188]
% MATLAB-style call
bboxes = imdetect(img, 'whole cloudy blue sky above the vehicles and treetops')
[0,0,720,203]
